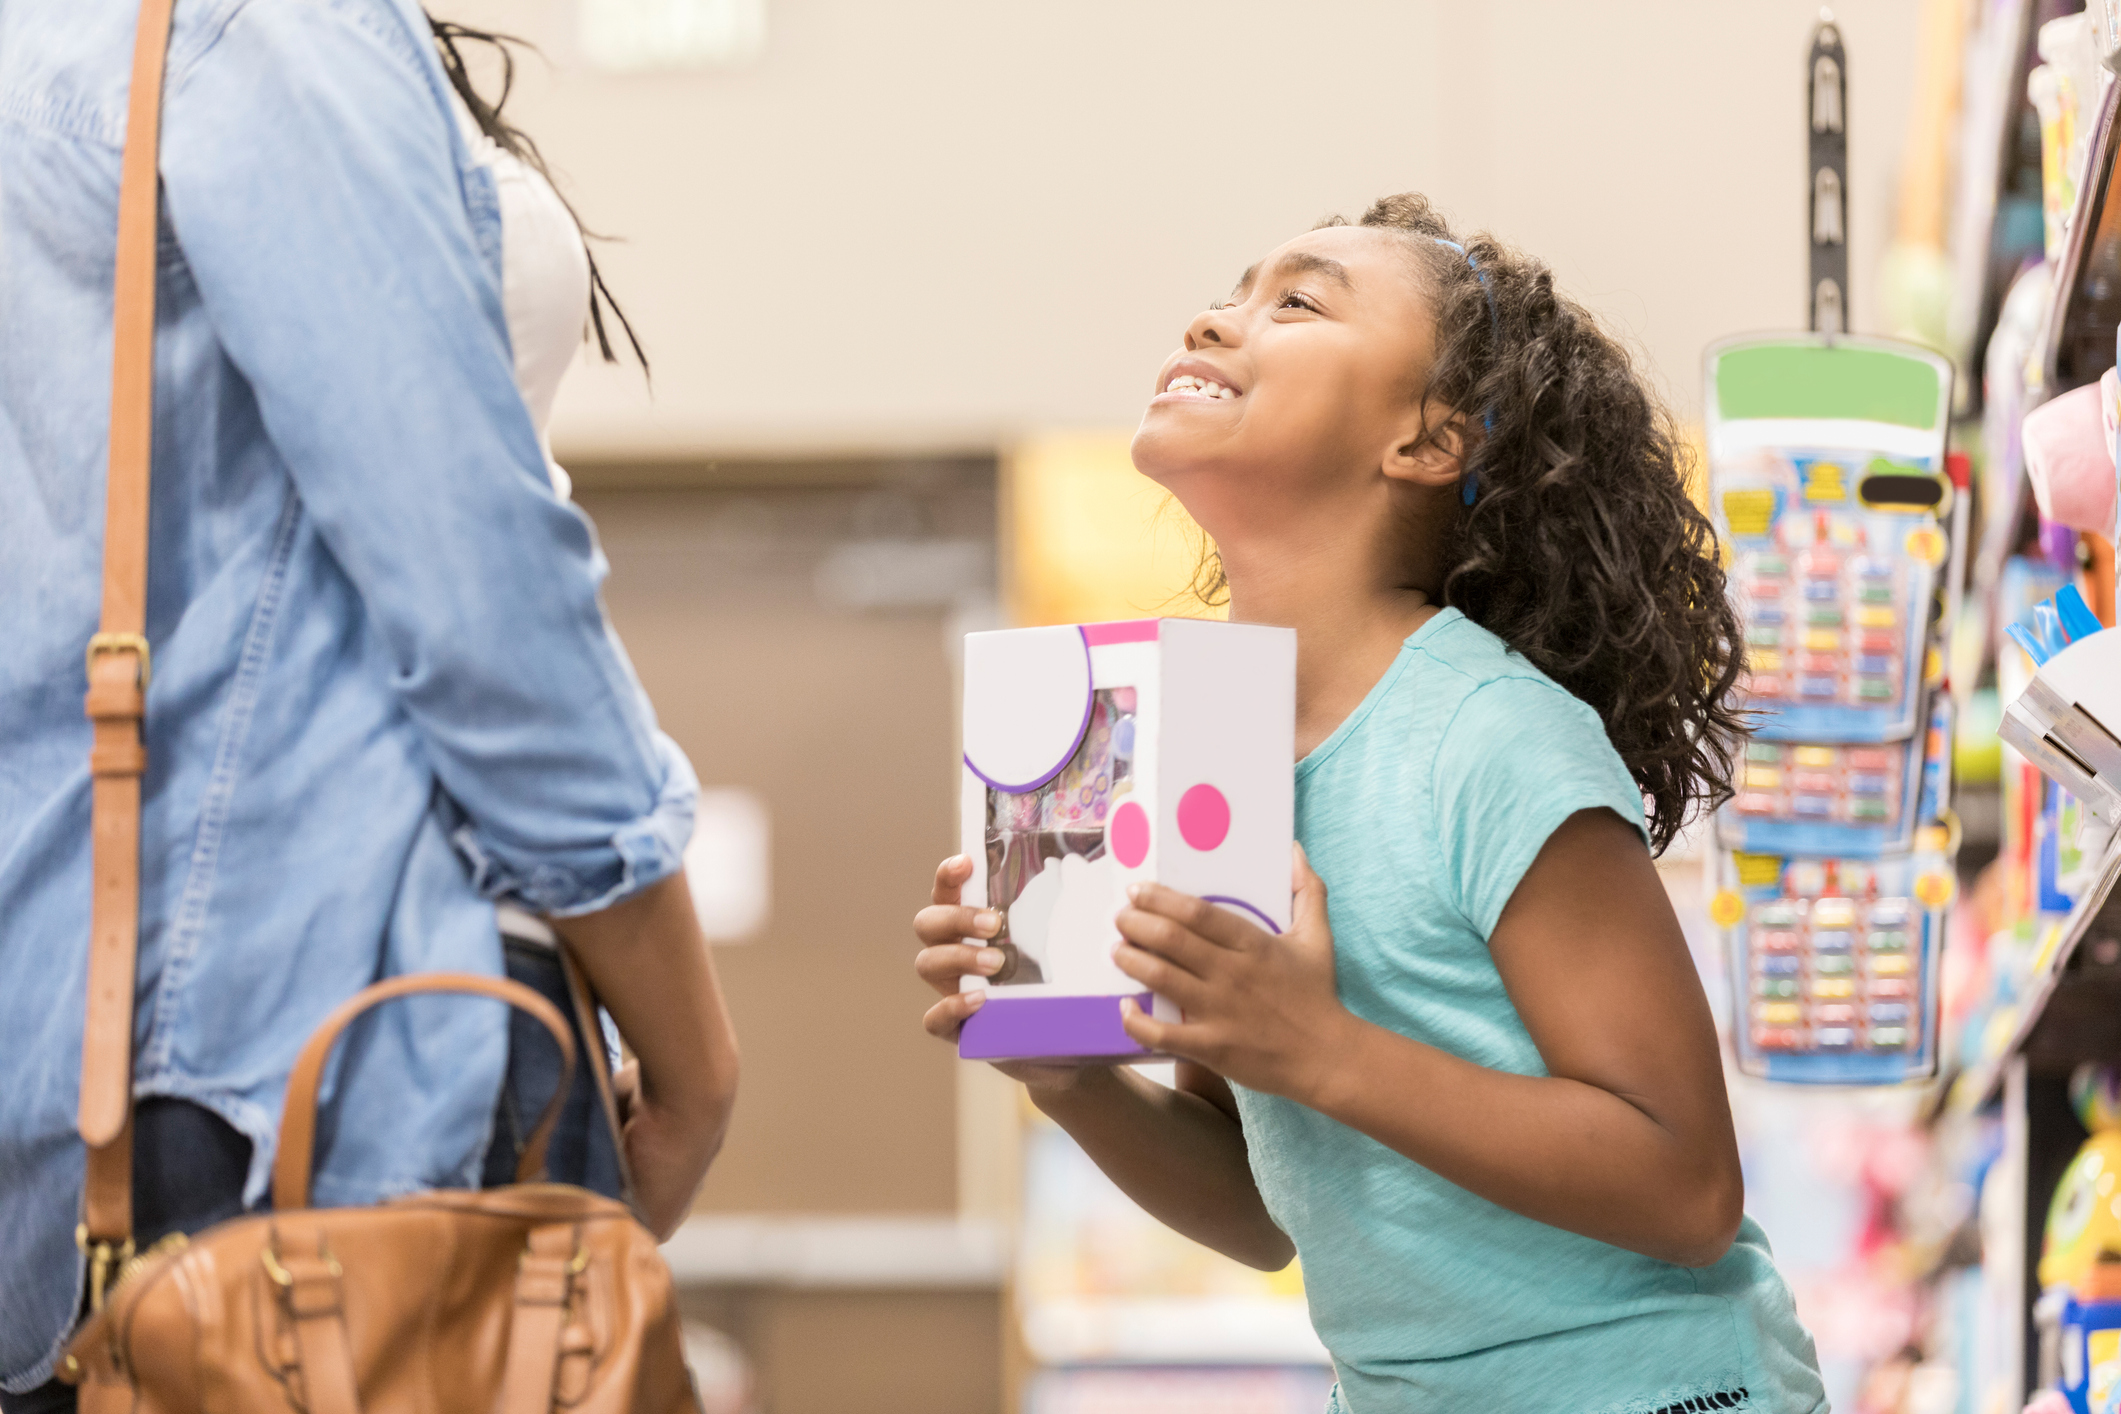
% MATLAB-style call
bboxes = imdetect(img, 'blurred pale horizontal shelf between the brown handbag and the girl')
[662,1215,1007,1291]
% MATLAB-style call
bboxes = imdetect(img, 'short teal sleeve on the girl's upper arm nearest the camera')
[1430,668,1648,937]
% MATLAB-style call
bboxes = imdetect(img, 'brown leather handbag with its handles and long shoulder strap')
[59,0,698,1414]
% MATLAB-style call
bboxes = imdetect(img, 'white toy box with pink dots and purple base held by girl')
[959,619,1296,1062]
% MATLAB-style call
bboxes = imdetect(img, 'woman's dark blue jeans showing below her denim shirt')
[0,939,619,1414]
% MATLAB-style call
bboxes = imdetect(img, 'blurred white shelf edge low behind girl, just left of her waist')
[1024,1295,1330,1365]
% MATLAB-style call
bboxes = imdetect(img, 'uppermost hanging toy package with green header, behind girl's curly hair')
[1705,335,1951,746]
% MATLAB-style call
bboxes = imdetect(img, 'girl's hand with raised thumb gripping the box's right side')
[1111,846,1355,1102]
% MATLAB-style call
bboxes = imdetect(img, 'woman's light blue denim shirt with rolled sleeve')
[0,0,696,1391]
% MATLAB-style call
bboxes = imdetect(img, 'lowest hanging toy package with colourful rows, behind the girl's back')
[1710,827,1951,1085]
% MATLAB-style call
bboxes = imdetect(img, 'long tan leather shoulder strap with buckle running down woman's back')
[74,0,174,1306]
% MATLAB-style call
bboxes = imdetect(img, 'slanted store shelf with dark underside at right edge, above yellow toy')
[1951,839,2121,1109]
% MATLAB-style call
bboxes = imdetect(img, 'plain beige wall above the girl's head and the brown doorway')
[431,0,1920,458]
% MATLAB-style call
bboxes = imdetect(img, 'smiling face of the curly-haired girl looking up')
[1133,227,1457,555]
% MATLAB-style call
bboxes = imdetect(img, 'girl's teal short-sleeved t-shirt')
[1237,608,1826,1414]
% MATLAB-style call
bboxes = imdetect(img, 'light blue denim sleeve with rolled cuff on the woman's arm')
[161,0,698,914]
